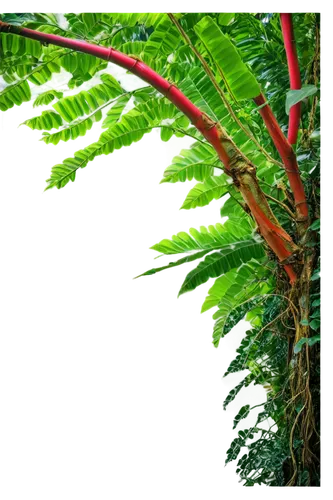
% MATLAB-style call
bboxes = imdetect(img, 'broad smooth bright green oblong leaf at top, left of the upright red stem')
[194,16,260,100]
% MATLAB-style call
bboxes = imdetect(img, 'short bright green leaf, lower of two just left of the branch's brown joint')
[178,173,232,212]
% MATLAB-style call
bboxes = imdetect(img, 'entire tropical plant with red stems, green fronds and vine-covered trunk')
[0,6,323,488]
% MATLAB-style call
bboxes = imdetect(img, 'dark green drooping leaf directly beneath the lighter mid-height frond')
[177,239,265,297]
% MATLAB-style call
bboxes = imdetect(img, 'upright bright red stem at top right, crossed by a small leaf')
[280,9,302,144]
